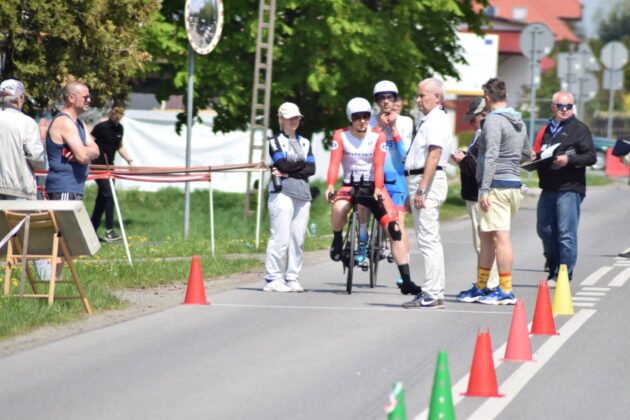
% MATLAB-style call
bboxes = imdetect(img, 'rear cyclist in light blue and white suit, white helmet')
[370,80,418,294]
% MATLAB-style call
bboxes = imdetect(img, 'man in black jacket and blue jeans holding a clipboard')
[536,91,597,281]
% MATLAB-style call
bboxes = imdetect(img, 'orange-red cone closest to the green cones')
[462,329,503,397]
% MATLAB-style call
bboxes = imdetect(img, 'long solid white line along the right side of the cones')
[468,309,597,419]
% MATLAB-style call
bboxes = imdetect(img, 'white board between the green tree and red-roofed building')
[444,32,499,96]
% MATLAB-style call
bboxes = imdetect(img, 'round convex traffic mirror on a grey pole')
[185,0,223,55]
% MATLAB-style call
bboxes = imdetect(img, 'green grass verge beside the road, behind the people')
[0,173,611,338]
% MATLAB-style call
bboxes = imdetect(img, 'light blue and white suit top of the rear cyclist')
[370,115,413,194]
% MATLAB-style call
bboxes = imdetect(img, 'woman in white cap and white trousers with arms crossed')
[263,102,315,292]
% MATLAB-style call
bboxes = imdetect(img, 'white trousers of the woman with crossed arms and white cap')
[265,193,311,282]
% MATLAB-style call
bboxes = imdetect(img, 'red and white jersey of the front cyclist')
[327,128,387,188]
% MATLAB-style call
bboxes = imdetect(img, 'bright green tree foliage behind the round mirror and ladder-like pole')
[145,0,487,139]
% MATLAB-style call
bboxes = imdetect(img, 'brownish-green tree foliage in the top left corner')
[0,0,160,112]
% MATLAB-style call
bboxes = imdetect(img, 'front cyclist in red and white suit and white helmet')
[326,98,420,296]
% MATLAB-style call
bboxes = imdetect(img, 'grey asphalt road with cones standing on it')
[0,185,630,419]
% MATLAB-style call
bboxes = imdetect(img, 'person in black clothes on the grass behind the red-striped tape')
[92,107,133,243]
